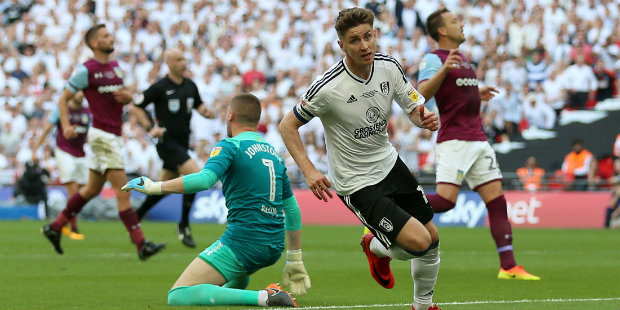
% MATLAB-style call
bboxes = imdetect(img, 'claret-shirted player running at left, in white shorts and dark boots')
[41,24,166,260]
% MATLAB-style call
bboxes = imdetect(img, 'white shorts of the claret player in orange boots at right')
[436,140,502,189]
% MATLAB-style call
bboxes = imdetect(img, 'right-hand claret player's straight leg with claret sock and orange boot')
[467,142,540,280]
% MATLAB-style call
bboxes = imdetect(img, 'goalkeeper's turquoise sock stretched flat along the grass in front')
[168,284,259,306]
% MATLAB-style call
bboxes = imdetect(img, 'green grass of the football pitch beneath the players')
[0,221,620,310]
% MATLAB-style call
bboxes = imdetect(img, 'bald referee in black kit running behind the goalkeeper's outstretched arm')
[130,48,214,248]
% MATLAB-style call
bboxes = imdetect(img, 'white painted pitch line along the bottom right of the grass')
[254,297,620,310]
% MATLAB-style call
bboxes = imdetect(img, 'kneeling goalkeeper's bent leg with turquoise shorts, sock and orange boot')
[168,240,295,306]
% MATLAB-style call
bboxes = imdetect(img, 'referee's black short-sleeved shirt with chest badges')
[136,76,202,147]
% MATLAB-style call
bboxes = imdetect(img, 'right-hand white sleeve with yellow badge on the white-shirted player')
[388,57,425,114]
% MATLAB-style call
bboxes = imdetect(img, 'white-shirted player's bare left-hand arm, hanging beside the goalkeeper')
[280,110,333,201]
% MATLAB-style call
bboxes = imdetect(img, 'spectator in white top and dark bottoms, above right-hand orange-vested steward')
[563,54,597,110]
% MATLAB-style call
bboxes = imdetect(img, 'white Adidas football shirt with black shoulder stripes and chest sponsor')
[293,53,424,196]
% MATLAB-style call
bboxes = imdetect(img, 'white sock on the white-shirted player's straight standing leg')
[411,245,441,310]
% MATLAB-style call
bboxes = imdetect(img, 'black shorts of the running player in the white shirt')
[338,157,433,248]
